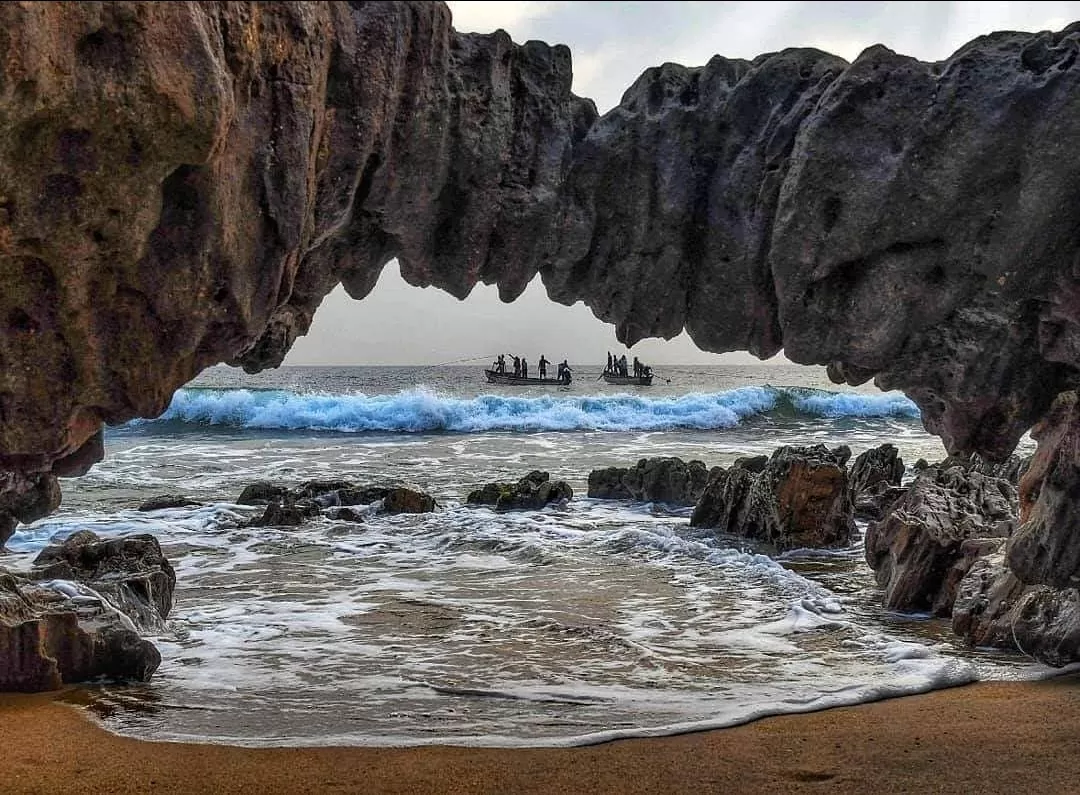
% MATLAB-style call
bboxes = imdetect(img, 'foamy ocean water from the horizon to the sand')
[5,365,1048,745]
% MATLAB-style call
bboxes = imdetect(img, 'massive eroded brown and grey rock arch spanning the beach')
[0,2,1080,656]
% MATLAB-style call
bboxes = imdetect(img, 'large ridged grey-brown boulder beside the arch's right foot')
[866,466,1016,616]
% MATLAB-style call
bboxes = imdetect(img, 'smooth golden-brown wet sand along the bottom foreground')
[0,675,1080,795]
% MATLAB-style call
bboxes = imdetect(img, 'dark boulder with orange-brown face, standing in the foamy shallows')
[690,445,854,550]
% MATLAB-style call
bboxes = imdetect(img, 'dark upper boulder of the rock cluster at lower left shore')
[30,530,176,632]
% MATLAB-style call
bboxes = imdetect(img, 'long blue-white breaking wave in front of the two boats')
[130,387,919,433]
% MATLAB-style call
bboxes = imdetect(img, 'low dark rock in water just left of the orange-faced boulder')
[589,458,708,506]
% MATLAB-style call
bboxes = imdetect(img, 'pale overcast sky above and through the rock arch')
[285,0,1080,364]
